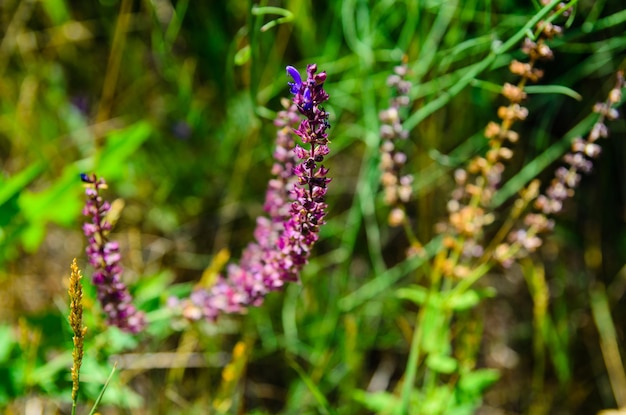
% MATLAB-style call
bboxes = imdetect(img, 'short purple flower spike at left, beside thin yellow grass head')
[80,174,146,333]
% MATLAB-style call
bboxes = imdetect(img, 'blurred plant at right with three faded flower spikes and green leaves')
[380,5,624,413]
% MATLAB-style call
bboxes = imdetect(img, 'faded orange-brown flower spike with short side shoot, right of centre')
[438,16,562,277]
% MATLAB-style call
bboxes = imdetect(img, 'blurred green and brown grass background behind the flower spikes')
[0,0,626,414]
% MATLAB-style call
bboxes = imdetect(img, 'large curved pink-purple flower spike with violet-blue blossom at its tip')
[170,65,331,320]
